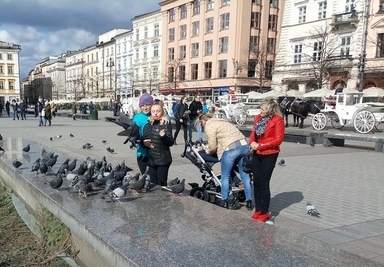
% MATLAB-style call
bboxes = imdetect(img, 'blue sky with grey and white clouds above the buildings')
[0,0,161,79]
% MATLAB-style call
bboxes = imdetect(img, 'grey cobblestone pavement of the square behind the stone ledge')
[0,112,384,265]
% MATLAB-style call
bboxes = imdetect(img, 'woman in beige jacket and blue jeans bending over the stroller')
[197,114,253,210]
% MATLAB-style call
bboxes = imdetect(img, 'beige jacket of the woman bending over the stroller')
[204,118,245,159]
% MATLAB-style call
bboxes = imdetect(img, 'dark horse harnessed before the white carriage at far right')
[277,96,323,128]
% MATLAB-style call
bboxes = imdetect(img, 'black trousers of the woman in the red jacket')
[252,153,279,214]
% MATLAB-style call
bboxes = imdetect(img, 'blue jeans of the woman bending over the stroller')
[221,145,252,200]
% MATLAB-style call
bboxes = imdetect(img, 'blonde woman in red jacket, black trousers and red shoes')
[249,100,285,222]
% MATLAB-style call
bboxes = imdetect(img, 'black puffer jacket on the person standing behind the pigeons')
[141,121,173,166]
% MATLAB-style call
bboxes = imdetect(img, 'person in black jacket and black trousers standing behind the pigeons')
[142,103,173,186]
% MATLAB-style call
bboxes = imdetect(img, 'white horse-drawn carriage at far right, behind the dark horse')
[312,92,384,133]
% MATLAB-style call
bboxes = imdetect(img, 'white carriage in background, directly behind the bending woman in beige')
[214,94,260,125]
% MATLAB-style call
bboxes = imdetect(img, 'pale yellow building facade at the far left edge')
[0,41,21,105]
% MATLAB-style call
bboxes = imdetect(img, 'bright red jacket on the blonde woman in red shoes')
[249,115,285,155]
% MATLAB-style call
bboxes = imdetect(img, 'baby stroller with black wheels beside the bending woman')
[184,141,245,209]
